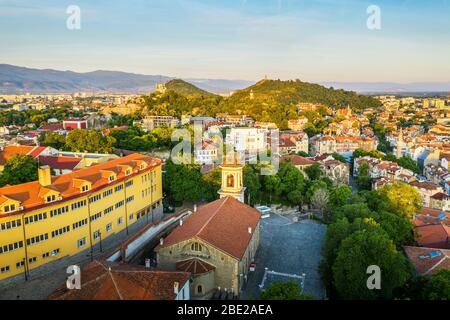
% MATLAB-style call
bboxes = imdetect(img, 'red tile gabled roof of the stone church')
[155,197,261,260]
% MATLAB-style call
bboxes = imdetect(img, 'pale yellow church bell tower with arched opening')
[219,152,245,203]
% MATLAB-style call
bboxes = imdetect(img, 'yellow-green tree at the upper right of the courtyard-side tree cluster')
[380,181,423,219]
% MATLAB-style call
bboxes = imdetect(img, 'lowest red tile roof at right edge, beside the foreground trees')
[403,246,450,275]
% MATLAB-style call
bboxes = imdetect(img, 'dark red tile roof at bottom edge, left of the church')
[48,261,190,300]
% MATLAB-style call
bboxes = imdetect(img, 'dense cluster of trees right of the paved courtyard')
[320,182,449,300]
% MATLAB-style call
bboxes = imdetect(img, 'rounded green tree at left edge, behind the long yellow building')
[0,153,38,187]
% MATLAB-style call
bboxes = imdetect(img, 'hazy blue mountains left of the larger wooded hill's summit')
[0,64,254,94]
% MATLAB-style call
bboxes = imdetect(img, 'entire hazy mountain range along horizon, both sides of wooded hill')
[0,64,450,94]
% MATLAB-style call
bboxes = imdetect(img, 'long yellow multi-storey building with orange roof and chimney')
[0,154,162,280]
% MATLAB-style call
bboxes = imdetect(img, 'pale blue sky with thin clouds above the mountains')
[0,0,450,83]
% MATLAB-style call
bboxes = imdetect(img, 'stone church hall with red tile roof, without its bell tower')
[155,196,261,299]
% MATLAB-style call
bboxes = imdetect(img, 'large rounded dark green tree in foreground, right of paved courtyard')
[332,231,412,300]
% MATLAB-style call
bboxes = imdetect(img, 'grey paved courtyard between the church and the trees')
[242,214,326,299]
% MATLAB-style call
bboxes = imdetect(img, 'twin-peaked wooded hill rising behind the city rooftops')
[145,80,381,128]
